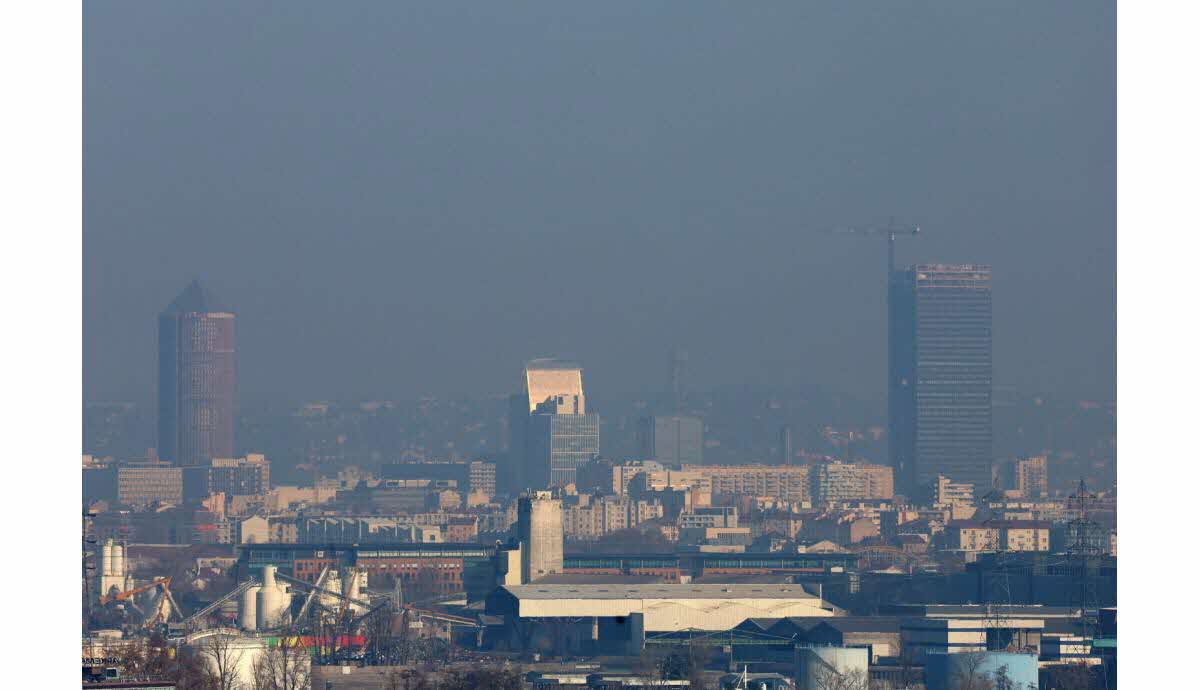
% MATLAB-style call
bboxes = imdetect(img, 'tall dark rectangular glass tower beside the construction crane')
[888,264,992,496]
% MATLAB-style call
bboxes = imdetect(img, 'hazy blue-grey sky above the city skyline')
[83,0,1116,400]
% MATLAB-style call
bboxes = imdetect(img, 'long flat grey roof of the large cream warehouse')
[504,583,816,599]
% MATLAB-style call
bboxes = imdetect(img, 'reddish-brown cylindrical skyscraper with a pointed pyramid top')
[158,281,236,467]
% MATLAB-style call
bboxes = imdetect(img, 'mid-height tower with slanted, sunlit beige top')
[505,359,600,492]
